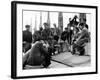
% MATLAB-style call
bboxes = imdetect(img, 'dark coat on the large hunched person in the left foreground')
[23,41,48,66]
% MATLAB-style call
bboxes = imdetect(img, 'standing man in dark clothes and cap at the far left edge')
[23,25,32,53]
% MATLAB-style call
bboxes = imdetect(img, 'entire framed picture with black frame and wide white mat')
[12,2,97,77]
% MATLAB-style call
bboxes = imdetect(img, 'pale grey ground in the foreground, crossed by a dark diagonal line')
[25,52,91,69]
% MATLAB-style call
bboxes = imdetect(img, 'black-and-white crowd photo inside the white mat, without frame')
[22,11,91,69]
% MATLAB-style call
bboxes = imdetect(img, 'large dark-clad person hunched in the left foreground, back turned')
[23,40,51,68]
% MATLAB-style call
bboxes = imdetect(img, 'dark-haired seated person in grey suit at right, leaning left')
[72,23,90,55]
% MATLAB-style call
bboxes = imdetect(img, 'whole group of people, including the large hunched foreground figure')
[23,16,90,67]
